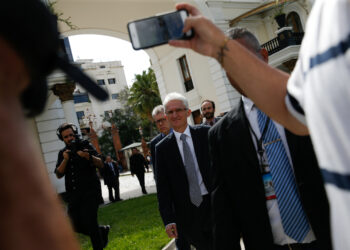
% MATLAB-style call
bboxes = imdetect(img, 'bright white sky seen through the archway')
[69,35,150,87]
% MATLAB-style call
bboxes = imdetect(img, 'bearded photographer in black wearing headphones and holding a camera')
[55,123,110,250]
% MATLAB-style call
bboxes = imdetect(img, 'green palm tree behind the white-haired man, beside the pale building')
[128,68,162,122]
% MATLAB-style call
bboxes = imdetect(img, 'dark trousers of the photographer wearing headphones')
[68,192,104,250]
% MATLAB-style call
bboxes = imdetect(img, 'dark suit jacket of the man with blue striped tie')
[209,102,331,250]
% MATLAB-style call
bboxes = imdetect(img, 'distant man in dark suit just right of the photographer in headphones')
[103,155,121,202]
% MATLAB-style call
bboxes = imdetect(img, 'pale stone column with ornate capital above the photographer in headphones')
[52,82,81,134]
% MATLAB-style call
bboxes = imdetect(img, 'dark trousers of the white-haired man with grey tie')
[178,195,213,250]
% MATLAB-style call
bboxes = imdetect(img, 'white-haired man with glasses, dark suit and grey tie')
[155,93,212,250]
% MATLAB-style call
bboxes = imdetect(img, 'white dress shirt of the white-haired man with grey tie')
[174,125,208,195]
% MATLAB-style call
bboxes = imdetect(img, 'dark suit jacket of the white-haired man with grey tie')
[156,125,211,228]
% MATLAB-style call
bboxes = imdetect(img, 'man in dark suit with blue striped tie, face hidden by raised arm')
[209,29,332,250]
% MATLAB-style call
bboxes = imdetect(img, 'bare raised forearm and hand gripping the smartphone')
[169,3,309,135]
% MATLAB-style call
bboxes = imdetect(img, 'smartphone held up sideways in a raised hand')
[128,10,193,50]
